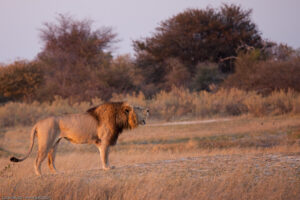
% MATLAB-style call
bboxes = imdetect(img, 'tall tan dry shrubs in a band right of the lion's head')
[149,88,300,120]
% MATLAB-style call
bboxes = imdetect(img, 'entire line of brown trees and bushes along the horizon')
[0,4,300,103]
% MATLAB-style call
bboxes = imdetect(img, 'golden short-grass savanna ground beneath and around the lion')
[0,115,300,199]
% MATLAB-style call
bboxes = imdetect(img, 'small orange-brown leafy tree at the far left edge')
[0,61,43,102]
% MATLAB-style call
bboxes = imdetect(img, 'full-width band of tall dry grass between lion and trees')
[0,88,300,127]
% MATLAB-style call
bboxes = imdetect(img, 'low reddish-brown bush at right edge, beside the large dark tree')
[223,51,300,95]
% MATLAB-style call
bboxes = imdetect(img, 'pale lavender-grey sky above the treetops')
[0,0,300,64]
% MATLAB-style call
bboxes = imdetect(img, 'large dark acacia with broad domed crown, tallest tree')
[133,4,262,93]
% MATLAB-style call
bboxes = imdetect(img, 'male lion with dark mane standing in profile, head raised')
[10,102,149,175]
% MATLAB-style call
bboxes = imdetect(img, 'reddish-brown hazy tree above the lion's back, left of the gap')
[38,15,117,100]
